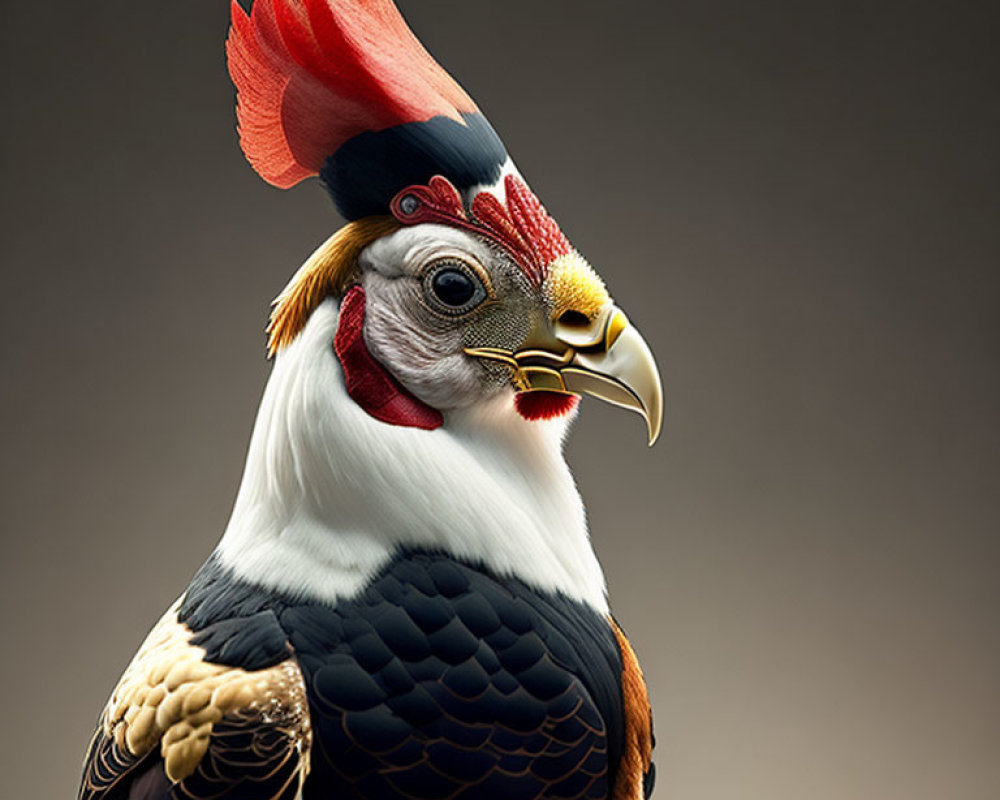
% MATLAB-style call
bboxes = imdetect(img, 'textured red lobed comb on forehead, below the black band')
[391,175,573,286]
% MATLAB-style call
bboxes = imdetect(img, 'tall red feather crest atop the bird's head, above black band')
[226,0,477,189]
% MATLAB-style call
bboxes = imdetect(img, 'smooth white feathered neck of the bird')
[218,300,607,612]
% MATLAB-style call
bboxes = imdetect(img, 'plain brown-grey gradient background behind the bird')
[0,0,1000,800]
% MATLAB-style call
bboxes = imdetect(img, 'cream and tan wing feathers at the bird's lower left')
[79,605,311,800]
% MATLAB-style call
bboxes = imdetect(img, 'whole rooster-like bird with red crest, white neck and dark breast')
[78,0,663,800]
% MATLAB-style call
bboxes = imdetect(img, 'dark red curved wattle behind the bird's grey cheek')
[333,286,444,431]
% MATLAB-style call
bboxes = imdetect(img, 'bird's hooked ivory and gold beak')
[465,303,663,446]
